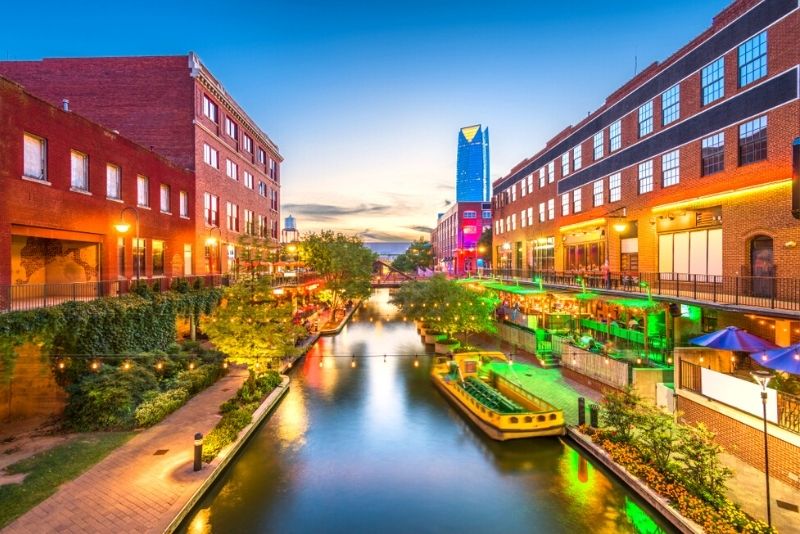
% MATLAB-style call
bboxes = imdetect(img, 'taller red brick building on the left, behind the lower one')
[0,53,283,274]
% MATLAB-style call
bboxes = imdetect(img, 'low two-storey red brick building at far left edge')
[0,78,197,302]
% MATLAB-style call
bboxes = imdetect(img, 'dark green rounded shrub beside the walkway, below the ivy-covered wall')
[64,365,158,432]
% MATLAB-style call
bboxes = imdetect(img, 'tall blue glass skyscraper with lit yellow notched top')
[456,124,490,202]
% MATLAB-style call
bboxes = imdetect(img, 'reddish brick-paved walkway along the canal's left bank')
[2,367,247,534]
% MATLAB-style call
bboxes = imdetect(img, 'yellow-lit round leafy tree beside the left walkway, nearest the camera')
[205,277,305,370]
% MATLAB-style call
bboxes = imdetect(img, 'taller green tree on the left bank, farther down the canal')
[299,230,377,310]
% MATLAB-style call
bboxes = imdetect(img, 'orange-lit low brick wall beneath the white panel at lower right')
[678,395,800,489]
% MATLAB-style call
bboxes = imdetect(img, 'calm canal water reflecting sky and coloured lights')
[186,290,672,534]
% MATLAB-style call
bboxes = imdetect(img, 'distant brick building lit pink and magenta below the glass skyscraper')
[431,202,492,274]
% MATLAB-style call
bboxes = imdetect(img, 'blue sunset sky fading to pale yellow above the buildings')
[0,0,729,241]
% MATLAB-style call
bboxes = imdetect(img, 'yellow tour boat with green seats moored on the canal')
[431,352,565,441]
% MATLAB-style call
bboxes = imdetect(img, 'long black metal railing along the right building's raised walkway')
[479,269,800,311]
